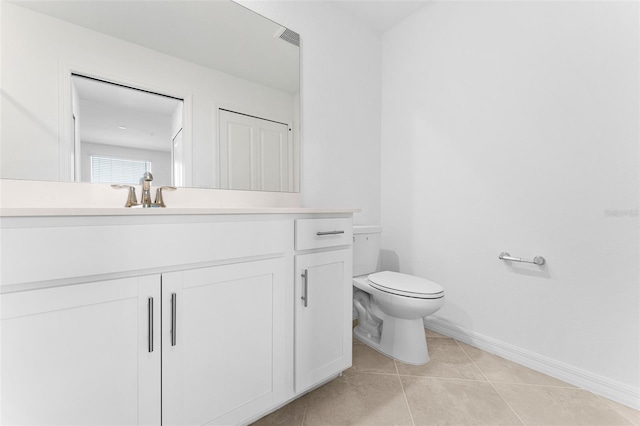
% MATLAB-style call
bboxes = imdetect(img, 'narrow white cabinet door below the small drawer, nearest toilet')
[295,249,352,393]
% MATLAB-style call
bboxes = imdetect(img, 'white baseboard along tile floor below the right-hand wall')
[424,317,640,410]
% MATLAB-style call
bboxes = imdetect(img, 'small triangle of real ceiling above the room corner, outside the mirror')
[332,0,429,34]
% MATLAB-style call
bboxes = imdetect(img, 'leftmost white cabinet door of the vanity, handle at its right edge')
[0,275,161,425]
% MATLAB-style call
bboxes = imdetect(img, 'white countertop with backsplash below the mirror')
[0,179,360,217]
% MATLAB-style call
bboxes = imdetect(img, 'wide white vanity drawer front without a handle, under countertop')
[0,217,293,286]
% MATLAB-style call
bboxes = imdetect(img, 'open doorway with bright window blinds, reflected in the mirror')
[71,75,182,186]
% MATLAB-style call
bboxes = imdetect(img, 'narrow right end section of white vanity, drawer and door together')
[295,218,353,393]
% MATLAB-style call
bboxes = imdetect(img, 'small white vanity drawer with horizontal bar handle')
[296,218,353,250]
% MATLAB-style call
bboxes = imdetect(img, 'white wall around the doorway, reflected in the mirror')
[0,2,297,187]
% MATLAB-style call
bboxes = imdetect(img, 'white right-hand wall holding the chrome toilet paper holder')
[382,2,640,405]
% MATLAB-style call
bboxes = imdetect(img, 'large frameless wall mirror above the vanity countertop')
[0,0,300,192]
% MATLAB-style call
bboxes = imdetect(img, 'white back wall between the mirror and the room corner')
[240,1,380,224]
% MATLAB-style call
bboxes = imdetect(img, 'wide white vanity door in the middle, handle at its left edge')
[162,259,292,425]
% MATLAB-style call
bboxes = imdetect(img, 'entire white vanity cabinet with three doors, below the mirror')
[0,208,353,425]
